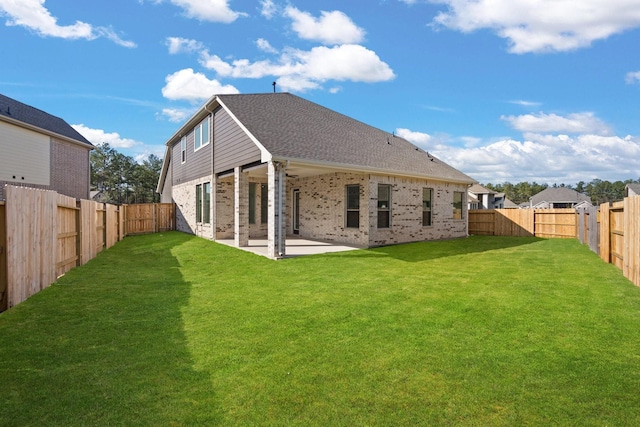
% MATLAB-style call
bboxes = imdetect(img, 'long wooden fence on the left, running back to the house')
[0,186,175,311]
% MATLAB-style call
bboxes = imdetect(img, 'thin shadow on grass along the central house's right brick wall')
[341,236,543,262]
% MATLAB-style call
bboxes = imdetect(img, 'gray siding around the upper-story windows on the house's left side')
[171,117,213,185]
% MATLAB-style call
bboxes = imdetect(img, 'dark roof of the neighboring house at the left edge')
[0,94,93,146]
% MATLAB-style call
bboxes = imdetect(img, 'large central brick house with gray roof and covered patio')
[157,93,474,258]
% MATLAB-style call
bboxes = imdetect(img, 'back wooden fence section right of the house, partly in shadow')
[469,209,577,238]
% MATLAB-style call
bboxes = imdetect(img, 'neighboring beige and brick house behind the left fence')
[0,95,93,200]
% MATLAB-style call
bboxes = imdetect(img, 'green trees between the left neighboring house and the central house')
[90,143,162,204]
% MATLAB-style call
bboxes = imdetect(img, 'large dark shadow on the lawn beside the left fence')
[0,233,220,426]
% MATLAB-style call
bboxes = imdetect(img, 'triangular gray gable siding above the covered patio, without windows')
[213,109,260,173]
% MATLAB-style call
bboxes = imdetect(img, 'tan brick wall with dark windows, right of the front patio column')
[287,173,467,246]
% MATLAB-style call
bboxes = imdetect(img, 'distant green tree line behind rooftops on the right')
[482,179,640,205]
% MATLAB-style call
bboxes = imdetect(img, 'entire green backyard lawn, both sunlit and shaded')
[0,233,640,426]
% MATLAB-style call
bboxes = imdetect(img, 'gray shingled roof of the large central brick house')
[218,93,475,184]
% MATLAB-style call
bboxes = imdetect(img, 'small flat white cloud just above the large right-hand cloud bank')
[501,112,611,135]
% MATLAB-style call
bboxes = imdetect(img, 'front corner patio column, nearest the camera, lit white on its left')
[267,162,287,258]
